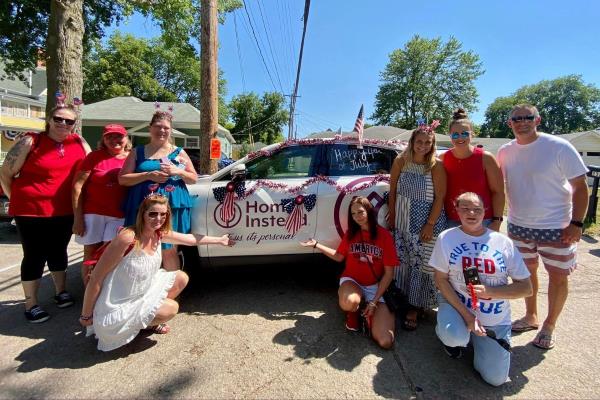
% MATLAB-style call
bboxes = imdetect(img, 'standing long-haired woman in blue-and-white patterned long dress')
[388,121,446,330]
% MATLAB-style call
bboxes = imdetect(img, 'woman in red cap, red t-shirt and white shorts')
[73,124,131,285]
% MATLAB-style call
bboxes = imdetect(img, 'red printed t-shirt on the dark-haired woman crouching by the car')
[337,226,399,286]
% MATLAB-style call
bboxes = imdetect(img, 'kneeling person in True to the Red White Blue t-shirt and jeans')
[429,192,531,386]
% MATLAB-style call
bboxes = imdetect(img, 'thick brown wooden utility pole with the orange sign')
[198,0,219,174]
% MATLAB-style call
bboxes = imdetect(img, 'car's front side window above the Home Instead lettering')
[246,146,317,179]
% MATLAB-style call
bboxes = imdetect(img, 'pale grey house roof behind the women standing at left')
[82,96,235,143]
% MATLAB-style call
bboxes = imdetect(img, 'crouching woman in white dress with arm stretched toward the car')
[79,194,234,351]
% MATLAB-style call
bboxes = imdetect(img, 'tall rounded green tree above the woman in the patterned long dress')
[371,35,484,129]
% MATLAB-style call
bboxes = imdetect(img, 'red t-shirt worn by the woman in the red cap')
[79,149,127,218]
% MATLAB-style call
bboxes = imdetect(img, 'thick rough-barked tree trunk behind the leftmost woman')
[46,0,85,132]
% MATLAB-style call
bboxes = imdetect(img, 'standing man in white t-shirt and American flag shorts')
[498,104,588,350]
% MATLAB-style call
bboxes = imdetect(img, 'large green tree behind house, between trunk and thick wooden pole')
[83,32,228,124]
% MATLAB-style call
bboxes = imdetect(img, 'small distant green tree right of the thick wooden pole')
[229,92,289,144]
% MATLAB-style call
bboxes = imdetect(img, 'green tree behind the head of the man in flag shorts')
[482,75,600,137]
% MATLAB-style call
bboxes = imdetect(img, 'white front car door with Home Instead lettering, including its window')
[207,145,319,258]
